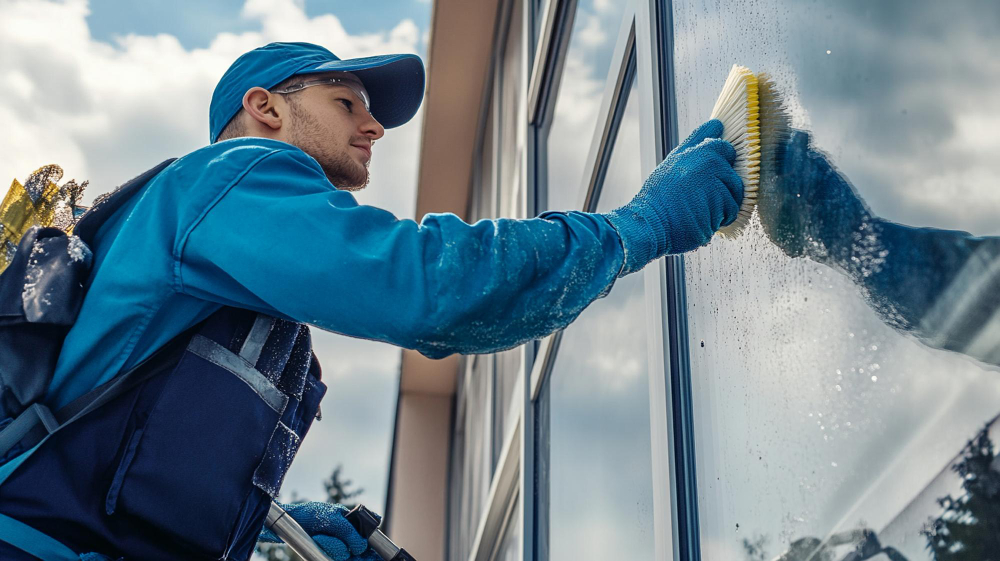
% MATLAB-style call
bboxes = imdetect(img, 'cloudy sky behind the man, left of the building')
[0,0,431,512]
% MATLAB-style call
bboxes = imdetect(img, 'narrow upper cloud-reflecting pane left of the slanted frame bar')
[539,0,631,210]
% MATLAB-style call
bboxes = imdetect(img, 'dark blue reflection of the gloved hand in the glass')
[758,130,875,265]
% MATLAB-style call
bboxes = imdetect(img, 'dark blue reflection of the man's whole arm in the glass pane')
[760,131,1000,364]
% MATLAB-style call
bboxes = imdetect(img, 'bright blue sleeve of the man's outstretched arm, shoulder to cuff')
[174,151,624,358]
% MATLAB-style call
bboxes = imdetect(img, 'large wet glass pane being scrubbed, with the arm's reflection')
[673,0,1000,561]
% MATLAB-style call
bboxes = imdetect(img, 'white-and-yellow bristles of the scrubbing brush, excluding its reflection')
[711,64,760,237]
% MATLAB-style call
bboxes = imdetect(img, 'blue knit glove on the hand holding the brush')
[605,119,743,275]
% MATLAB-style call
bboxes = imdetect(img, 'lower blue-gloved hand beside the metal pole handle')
[258,502,379,561]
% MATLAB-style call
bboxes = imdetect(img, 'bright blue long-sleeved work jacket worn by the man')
[47,138,624,408]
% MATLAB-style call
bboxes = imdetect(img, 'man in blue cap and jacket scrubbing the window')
[0,43,743,561]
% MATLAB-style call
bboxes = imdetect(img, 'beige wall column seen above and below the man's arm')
[385,0,498,560]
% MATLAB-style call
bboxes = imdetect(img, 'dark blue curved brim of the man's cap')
[295,54,424,129]
